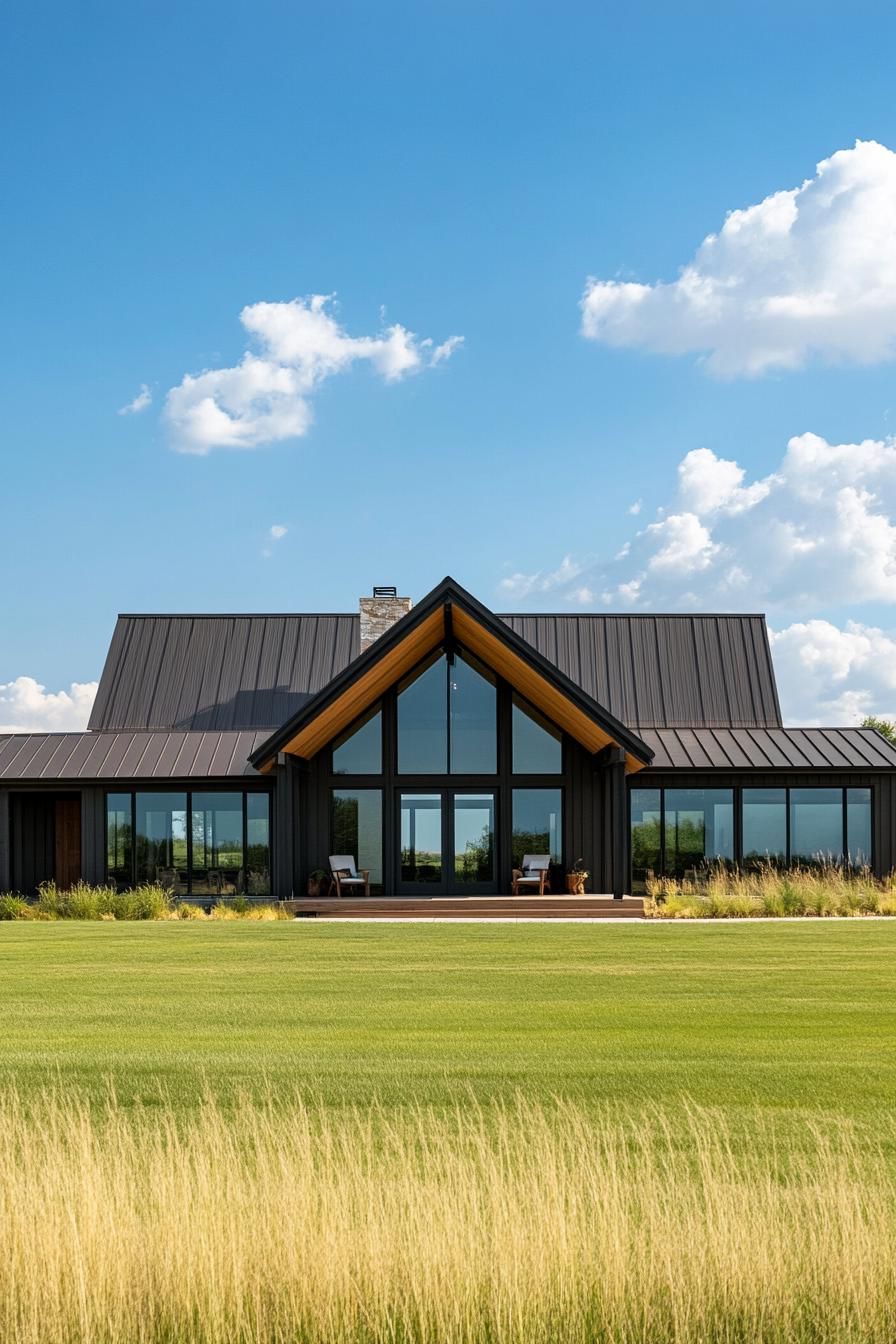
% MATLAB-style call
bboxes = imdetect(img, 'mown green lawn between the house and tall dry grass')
[0,921,896,1128]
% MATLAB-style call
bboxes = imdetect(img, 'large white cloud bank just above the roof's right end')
[498,433,896,724]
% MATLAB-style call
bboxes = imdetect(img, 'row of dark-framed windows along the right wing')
[631,788,872,890]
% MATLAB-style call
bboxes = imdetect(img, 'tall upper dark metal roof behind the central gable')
[90,614,780,732]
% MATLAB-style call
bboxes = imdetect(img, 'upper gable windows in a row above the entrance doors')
[333,653,563,775]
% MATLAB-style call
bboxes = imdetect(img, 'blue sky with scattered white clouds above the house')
[0,3,896,727]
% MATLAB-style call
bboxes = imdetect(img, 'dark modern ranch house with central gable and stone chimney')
[0,578,896,913]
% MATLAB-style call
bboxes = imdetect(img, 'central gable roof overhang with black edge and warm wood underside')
[250,578,653,773]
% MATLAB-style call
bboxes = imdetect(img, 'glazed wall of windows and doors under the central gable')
[321,645,572,894]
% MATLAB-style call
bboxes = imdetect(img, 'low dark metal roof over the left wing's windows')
[0,731,267,781]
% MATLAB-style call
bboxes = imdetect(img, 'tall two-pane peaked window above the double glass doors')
[398,652,497,774]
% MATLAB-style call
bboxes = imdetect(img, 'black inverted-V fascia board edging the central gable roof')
[249,575,653,770]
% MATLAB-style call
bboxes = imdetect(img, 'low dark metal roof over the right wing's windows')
[642,728,896,770]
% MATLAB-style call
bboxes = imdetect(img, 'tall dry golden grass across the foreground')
[0,1093,896,1344]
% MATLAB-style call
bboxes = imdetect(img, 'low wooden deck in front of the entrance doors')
[286,895,643,919]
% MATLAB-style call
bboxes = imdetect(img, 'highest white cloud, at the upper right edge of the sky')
[582,140,896,376]
